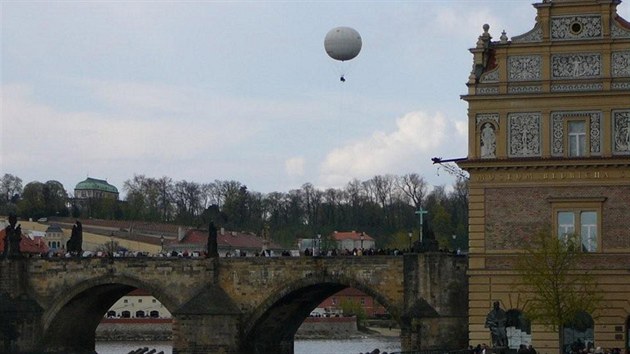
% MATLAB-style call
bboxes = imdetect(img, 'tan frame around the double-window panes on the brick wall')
[549,197,606,253]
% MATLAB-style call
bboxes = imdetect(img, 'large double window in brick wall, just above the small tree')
[551,198,605,252]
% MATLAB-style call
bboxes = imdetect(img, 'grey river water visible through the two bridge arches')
[96,337,400,354]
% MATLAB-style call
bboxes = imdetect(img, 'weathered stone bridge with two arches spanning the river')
[0,253,468,354]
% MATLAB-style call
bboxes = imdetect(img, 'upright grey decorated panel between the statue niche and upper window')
[508,113,541,157]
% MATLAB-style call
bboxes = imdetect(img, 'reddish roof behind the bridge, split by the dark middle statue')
[170,230,282,249]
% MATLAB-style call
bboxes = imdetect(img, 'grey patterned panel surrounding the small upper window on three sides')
[551,112,602,156]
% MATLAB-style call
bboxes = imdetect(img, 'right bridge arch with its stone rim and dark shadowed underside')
[243,274,401,353]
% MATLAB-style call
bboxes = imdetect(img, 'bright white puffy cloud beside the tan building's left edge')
[320,111,466,187]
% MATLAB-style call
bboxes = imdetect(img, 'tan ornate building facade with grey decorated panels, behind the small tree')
[459,0,630,353]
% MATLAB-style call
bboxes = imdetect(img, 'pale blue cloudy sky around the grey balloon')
[0,0,630,195]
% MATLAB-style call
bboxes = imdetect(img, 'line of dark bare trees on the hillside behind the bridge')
[0,173,468,250]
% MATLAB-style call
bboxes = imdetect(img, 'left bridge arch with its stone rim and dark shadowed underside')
[42,275,178,353]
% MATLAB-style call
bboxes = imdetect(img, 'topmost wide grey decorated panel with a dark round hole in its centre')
[551,15,602,40]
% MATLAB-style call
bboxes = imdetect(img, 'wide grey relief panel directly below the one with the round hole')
[551,53,602,79]
